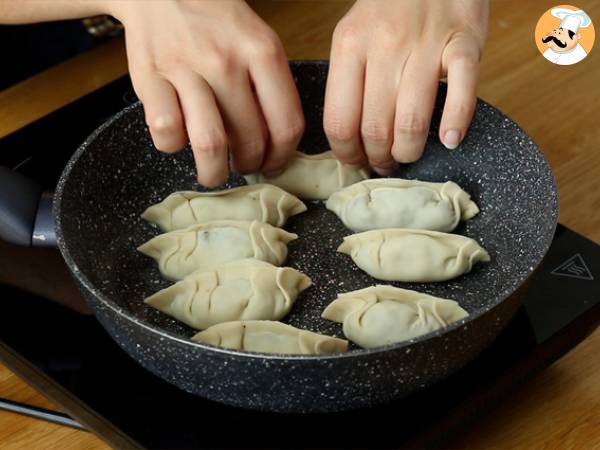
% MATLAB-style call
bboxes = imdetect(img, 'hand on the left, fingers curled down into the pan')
[107,0,304,186]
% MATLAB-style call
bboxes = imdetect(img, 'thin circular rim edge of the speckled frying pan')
[53,60,558,362]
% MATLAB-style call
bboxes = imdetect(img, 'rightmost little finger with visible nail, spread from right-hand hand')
[439,38,479,149]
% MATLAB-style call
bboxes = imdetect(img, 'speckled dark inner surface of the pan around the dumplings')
[57,62,557,352]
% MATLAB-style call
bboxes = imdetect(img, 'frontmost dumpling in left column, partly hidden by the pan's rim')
[192,320,348,355]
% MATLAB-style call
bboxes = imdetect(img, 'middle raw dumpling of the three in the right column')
[338,228,490,282]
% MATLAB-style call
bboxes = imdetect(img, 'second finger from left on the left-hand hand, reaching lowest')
[174,72,227,187]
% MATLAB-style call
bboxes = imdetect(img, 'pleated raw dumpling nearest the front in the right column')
[322,285,469,348]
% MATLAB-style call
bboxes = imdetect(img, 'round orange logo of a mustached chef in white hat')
[535,5,595,66]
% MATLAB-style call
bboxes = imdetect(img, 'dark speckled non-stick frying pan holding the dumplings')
[0,61,557,412]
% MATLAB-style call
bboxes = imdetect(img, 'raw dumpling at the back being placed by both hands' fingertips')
[244,151,369,200]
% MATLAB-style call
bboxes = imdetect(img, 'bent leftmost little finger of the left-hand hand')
[131,71,187,153]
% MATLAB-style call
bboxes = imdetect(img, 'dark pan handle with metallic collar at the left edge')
[0,166,56,247]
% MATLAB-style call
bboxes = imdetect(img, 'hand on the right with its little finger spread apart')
[323,0,488,175]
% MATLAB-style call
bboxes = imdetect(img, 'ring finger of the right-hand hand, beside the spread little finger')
[392,53,440,163]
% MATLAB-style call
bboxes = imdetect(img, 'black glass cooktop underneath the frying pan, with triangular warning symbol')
[0,78,600,448]
